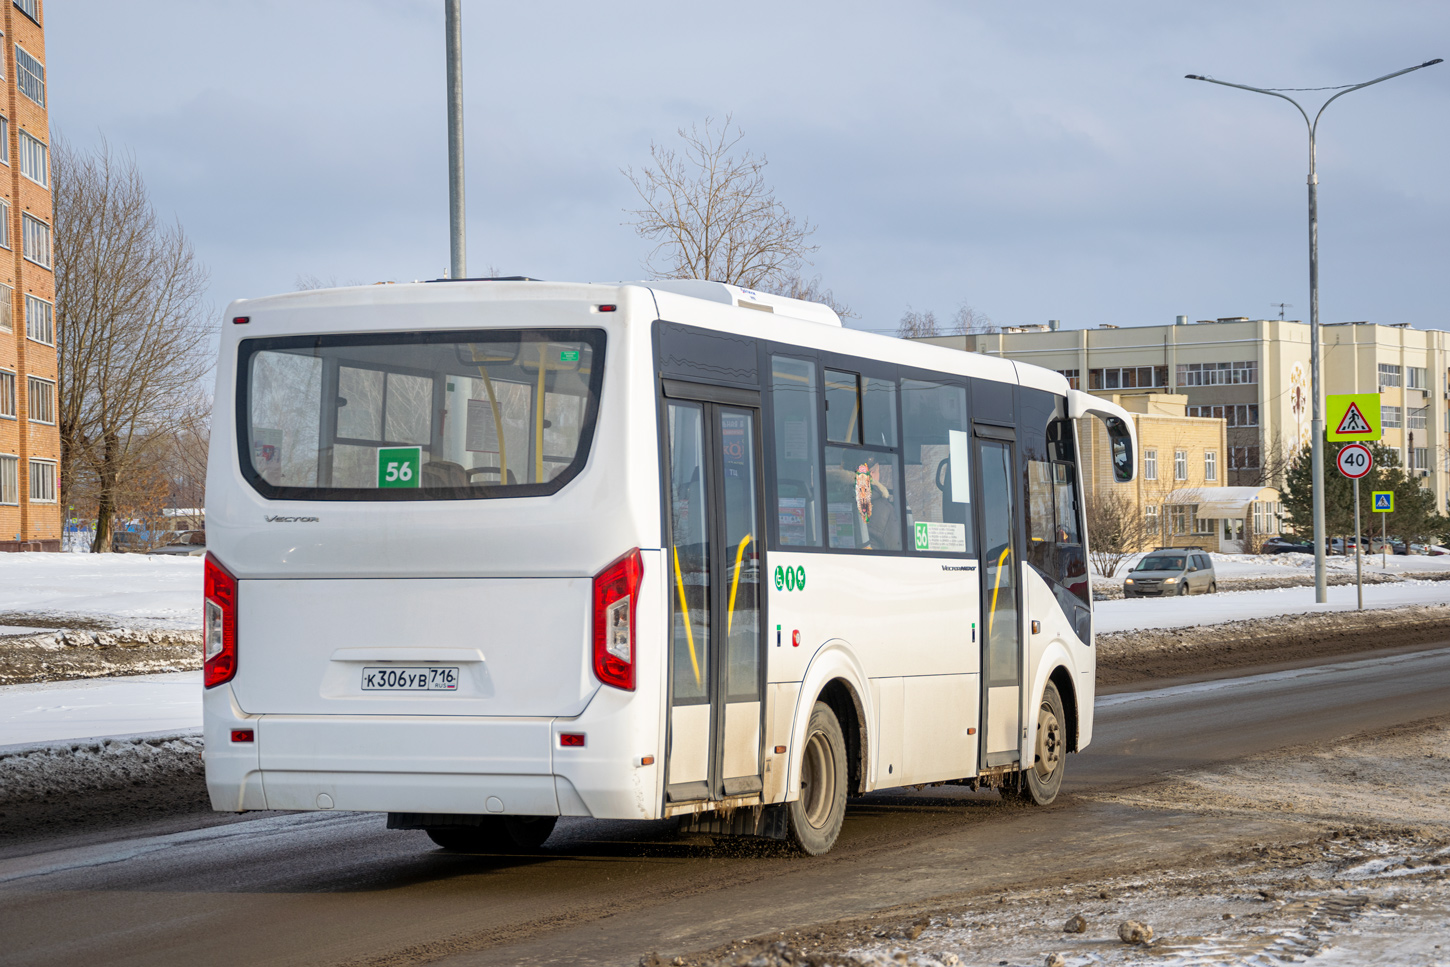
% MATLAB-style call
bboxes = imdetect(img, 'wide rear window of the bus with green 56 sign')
[238,329,605,500]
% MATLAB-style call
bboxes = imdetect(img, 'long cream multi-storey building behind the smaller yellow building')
[924,316,1450,507]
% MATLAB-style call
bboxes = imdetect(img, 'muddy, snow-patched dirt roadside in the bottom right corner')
[669,719,1450,967]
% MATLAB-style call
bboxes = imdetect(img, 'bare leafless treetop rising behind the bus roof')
[624,116,818,291]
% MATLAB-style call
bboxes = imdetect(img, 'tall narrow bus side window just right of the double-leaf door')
[770,355,821,547]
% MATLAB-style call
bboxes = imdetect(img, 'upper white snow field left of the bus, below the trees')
[0,554,202,631]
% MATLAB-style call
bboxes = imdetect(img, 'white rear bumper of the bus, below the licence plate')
[206,686,658,819]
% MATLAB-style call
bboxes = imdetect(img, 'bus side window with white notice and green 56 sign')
[902,380,976,554]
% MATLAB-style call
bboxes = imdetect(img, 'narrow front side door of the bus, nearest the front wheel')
[976,428,1022,768]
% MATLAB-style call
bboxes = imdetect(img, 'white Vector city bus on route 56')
[204,280,1135,854]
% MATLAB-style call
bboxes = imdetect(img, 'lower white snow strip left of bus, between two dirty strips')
[0,672,202,747]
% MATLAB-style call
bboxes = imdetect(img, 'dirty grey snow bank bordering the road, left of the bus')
[0,732,203,809]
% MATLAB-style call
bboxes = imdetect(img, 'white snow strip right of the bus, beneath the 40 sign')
[1093,581,1450,634]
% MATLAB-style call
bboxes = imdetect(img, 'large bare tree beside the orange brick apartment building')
[51,138,210,551]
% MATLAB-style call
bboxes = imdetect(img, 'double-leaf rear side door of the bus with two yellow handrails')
[666,400,764,803]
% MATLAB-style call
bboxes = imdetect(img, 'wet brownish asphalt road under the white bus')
[0,645,1450,967]
